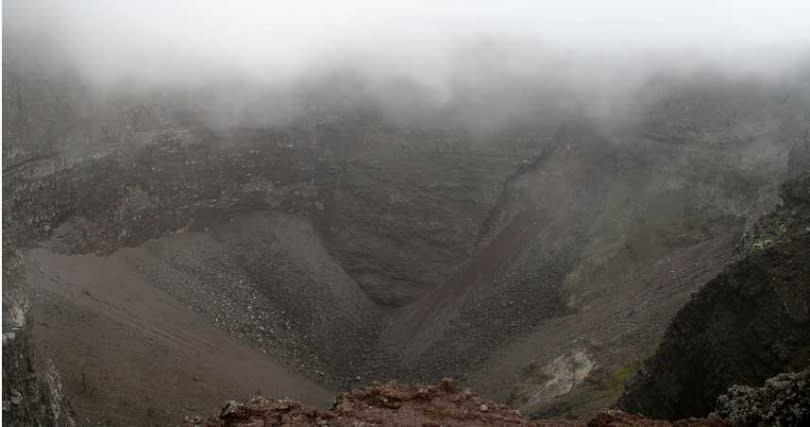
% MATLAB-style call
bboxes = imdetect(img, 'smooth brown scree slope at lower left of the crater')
[27,249,334,425]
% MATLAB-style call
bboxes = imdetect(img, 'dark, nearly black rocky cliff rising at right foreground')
[620,173,810,419]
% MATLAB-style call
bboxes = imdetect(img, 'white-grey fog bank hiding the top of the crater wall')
[3,0,810,127]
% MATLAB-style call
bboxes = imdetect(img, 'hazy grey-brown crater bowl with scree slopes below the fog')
[3,43,810,422]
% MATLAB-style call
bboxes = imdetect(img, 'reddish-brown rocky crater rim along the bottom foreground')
[183,378,728,427]
